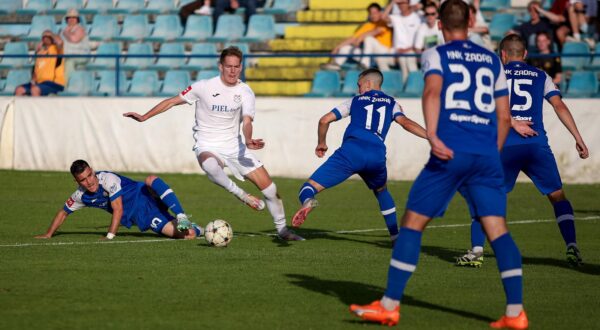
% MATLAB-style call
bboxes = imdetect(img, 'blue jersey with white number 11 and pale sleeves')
[332,90,404,148]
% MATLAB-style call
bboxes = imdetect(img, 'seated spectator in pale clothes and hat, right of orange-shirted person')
[61,9,90,77]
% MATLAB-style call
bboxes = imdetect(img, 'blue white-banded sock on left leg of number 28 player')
[385,227,423,300]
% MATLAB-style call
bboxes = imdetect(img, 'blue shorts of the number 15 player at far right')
[500,143,562,195]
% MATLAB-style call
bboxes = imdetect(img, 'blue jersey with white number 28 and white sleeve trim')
[421,40,508,155]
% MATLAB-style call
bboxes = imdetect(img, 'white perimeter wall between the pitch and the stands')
[0,97,600,183]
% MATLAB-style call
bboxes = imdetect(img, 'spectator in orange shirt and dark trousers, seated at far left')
[15,30,65,96]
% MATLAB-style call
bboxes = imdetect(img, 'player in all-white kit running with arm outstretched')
[123,47,304,241]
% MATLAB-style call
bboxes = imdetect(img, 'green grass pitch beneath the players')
[0,171,600,329]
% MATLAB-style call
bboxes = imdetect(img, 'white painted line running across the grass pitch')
[0,215,600,248]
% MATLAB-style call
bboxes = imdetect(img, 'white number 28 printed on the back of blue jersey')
[445,64,496,113]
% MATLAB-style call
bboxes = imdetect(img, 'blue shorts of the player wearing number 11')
[310,139,387,189]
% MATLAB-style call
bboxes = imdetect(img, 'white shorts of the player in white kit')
[194,143,263,181]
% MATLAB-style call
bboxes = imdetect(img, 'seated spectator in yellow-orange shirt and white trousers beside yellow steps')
[322,2,394,71]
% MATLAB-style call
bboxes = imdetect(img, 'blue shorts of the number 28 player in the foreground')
[406,152,506,218]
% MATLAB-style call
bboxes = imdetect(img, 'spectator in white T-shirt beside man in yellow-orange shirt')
[384,0,421,81]
